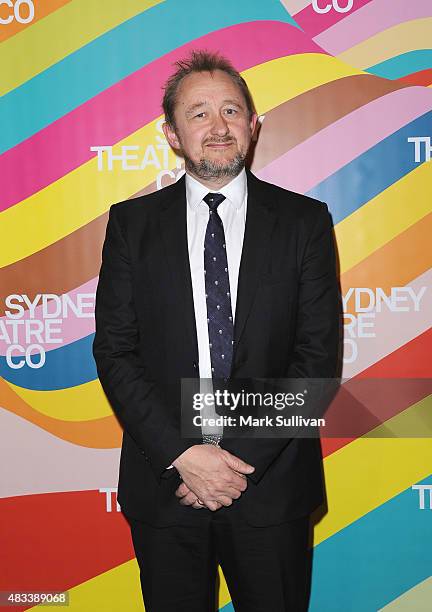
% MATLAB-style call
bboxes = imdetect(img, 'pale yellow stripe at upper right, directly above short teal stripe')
[338,17,432,68]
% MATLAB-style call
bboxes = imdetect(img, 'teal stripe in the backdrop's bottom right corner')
[310,477,432,612]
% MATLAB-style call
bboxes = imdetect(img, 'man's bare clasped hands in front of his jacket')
[173,444,255,511]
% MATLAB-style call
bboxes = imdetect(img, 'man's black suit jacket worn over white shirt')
[93,171,339,526]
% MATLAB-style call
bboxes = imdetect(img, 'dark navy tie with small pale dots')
[203,193,234,379]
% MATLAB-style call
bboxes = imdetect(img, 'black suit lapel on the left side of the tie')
[160,175,198,361]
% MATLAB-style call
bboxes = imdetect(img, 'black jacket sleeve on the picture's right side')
[222,204,339,483]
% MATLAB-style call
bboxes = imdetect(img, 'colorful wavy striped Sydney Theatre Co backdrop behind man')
[0,0,432,612]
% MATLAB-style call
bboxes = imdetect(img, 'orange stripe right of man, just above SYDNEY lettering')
[340,213,432,314]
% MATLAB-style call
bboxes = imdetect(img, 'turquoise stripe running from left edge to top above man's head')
[0,0,298,153]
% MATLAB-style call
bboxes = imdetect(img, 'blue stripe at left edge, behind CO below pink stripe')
[0,334,97,391]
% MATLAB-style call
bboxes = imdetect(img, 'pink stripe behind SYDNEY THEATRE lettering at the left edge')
[0,277,98,356]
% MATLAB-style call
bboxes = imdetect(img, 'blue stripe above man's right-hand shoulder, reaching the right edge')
[307,111,432,225]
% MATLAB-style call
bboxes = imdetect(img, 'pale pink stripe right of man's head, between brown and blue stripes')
[257,86,432,193]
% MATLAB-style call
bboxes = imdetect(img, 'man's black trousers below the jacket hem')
[128,508,312,612]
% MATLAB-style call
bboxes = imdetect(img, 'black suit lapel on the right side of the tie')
[234,171,276,360]
